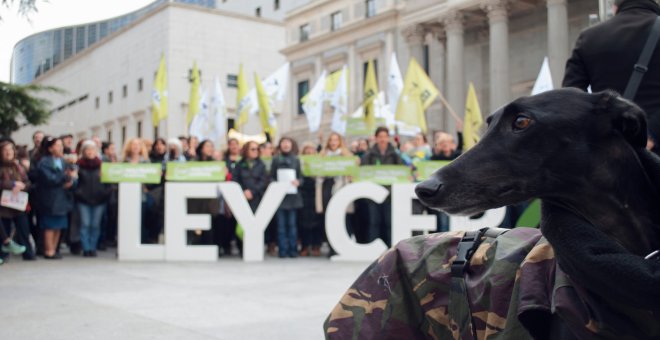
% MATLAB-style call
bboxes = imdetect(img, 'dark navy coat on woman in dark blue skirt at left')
[34,156,75,216]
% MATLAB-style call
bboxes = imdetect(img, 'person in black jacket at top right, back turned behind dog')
[562,0,660,152]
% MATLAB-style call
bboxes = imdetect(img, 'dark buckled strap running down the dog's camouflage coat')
[448,228,509,340]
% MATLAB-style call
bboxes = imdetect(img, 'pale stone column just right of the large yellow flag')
[442,11,467,125]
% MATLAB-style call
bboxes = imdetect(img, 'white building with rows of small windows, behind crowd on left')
[13,1,285,147]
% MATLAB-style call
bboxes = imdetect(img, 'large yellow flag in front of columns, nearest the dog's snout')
[396,58,439,133]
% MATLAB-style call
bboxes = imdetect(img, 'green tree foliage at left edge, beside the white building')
[0,82,63,137]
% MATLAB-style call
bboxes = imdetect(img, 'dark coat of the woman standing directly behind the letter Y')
[232,159,268,212]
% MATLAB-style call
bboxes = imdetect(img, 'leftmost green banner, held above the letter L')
[101,162,162,183]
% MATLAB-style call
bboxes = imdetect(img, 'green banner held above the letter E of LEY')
[165,162,225,182]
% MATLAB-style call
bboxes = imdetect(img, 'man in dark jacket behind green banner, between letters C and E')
[361,126,403,247]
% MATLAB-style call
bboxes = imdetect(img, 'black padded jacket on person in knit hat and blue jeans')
[75,159,112,205]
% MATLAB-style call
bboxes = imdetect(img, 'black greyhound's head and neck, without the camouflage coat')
[416,89,660,311]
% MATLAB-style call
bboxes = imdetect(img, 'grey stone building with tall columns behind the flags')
[282,0,599,140]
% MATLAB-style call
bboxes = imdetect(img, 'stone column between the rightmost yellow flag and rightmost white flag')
[483,0,511,111]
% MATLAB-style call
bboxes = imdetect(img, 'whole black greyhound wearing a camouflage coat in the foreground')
[324,89,660,339]
